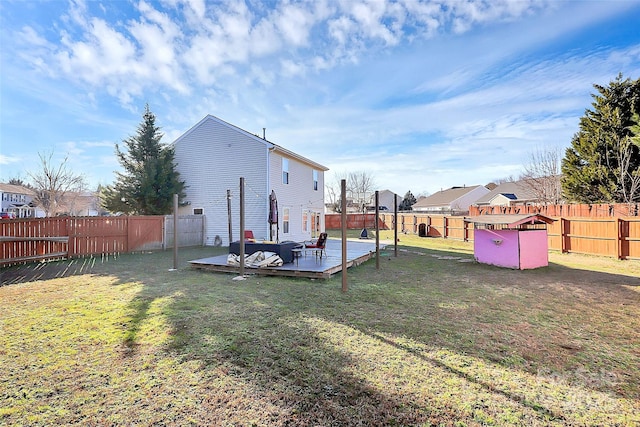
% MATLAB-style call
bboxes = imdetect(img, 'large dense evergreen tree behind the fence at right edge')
[562,75,640,203]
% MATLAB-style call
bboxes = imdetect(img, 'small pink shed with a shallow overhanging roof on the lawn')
[464,214,555,270]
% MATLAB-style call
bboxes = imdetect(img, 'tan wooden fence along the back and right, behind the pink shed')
[325,212,640,259]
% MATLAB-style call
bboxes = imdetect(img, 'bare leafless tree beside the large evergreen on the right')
[520,147,562,205]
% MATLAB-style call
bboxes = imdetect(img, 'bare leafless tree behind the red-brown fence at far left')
[27,151,85,216]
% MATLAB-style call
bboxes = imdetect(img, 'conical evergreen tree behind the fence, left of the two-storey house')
[102,105,185,215]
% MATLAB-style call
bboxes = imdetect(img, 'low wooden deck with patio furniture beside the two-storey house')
[189,239,384,279]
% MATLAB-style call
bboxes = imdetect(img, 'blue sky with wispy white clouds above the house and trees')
[0,0,640,195]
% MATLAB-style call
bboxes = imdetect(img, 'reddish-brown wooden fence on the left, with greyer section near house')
[0,215,204,265]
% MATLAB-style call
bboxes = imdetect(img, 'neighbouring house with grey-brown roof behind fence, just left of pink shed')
[412,185,489,215]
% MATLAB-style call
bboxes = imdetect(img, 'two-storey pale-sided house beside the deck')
[173,115,328,246]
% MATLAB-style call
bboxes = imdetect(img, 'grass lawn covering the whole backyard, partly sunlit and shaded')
[0,232,640,426]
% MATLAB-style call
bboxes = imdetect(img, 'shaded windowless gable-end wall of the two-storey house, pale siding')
[175,116,268,246]
